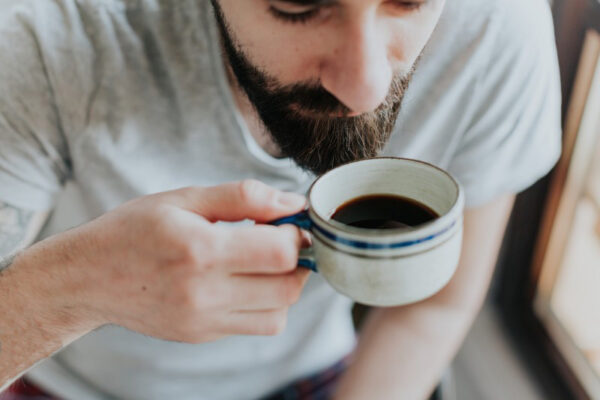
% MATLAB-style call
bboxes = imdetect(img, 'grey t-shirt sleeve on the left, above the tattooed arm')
[0,6,69,210]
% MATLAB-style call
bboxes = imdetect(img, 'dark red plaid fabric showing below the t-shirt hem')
[0,357,350,400]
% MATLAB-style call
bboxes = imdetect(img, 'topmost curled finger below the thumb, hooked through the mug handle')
[216,225,303,274]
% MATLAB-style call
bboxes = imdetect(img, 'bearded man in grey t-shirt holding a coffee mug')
[0,0,560,400]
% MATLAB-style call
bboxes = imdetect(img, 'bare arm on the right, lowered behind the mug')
[336,196,514,400]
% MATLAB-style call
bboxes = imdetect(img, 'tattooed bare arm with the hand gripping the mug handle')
[0,181,308,390]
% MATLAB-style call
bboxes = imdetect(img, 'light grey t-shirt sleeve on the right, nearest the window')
[448,0,561,207]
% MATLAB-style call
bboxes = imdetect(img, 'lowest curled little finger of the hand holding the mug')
[220,308,288,336]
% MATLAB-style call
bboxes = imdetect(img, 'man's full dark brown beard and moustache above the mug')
[211,0,416,175]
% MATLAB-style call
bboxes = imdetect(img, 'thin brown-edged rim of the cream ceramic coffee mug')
[307,156,464,238]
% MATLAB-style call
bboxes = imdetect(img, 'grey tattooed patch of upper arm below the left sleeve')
[0,202,35,271]
